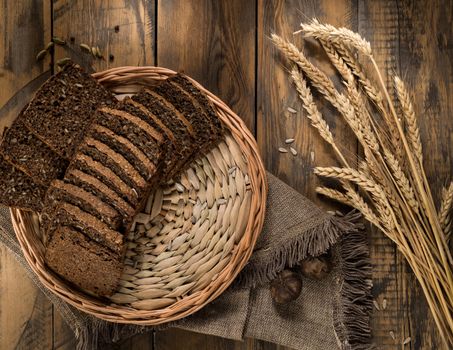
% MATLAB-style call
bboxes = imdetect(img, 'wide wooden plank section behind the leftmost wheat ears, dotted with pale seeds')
[257,0,357,208]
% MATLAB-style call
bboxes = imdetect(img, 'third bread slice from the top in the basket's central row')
[78,137,148,197]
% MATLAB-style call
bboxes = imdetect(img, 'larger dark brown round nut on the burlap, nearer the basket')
[270,270,302,304]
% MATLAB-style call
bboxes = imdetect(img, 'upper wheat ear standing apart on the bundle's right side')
[395,76,423,165]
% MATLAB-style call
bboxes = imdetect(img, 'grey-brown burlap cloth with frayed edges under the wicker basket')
[0,174,371,350]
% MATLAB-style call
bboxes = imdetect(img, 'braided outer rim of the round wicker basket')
[11,66,267,325]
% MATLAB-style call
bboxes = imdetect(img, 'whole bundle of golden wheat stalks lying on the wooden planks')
[272,20,453,347]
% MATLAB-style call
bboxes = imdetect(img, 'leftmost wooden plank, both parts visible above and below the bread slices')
[0,0,52,349]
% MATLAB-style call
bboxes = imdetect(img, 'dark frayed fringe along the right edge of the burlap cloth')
[334,223,374,350]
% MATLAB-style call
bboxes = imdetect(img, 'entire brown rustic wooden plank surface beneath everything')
[0,0,453,350]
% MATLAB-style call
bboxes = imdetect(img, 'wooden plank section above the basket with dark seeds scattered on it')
[53,0,155,71]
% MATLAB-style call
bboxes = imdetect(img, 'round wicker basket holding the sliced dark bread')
[11,67,267,325]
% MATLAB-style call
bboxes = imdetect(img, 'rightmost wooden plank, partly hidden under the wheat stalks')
[398,0,453,349]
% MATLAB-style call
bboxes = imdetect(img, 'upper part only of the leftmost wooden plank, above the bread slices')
[0,0,51,130]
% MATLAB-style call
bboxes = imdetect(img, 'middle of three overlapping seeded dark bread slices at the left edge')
[0,113,69,186]
